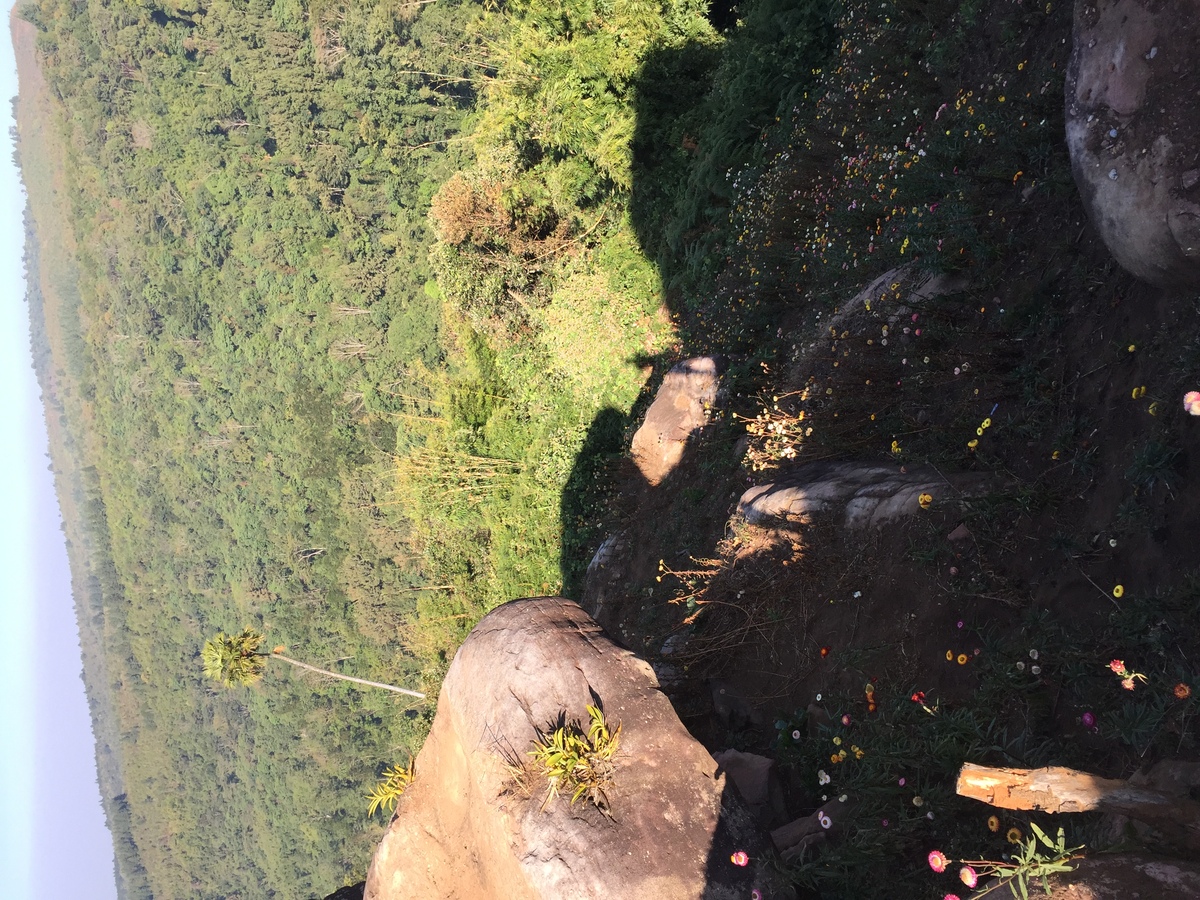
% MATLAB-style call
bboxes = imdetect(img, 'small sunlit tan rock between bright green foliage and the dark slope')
[630,356,725,485]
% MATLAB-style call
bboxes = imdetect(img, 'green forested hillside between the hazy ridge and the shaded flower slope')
[22,0,832,899]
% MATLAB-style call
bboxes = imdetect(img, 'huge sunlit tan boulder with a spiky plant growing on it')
[365,598,769,900]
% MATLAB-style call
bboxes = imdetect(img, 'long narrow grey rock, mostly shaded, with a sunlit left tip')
[738,462,995,528]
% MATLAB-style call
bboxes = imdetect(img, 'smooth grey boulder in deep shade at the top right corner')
[1067,0,1200,287]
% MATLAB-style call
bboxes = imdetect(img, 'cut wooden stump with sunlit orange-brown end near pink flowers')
[955,762,1200,850]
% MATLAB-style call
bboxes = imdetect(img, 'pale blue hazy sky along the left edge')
[0,2,116,900]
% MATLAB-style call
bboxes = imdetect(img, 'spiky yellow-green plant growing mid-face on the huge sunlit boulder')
[529,706,620,812]
